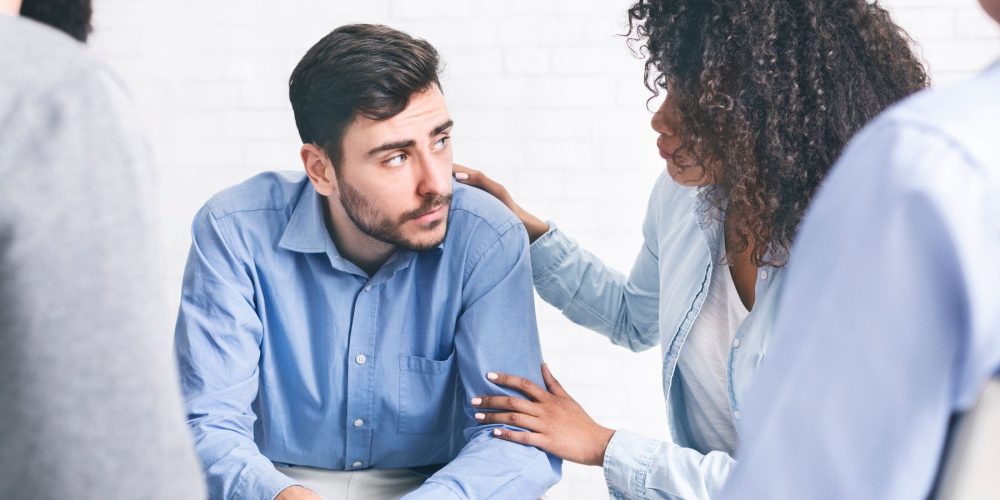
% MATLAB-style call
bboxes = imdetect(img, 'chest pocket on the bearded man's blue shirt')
[399,351,458,434]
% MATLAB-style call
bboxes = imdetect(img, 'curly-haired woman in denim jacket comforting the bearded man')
[456,0,928,498]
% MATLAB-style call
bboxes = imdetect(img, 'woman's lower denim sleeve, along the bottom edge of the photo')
[604,430,736,500]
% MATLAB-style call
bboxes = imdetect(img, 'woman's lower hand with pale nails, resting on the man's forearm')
[472,364,615,466]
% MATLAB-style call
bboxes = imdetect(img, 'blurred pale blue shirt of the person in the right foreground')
[724,60,1000,500]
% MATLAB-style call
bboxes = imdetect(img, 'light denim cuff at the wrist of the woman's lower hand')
[604,429,660,499]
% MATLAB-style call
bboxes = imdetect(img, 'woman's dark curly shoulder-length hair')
[626,0,929,266]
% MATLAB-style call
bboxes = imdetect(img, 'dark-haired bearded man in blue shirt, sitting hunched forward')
[176,25,561,499]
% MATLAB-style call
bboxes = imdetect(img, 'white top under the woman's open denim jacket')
[677,238,750,455]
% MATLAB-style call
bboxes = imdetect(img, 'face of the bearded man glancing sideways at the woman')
[331,85,452,254]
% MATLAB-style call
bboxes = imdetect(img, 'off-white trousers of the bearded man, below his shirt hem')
[276,465,426,500]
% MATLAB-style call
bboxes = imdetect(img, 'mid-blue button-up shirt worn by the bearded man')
[175,173,561,499]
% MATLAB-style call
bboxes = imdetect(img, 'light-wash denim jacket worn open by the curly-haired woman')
[530,173,781,499]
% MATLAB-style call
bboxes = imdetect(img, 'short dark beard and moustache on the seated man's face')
[337,176,452,252]
